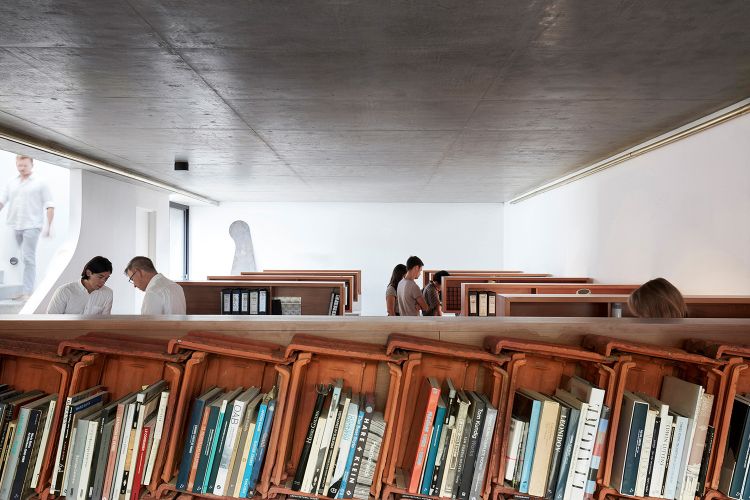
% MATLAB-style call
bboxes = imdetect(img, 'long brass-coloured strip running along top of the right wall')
[510,99,750,204]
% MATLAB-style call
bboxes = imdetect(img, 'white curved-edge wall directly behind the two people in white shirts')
[28,170,169,314]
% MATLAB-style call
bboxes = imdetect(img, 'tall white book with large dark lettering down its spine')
[566,376,604,500]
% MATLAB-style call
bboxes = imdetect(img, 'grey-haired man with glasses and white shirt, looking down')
[125,257,185,314]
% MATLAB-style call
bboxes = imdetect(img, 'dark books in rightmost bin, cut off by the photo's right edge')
[724,394,750,500]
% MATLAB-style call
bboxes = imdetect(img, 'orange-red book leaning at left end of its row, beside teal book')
[404,377,440,493]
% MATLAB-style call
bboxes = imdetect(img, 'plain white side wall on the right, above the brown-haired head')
[504,115,750,294]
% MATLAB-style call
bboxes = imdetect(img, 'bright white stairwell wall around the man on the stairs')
[0,151,70,292]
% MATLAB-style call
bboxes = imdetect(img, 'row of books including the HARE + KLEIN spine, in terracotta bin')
[291,379,386,500]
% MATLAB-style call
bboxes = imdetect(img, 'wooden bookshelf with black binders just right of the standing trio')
[458,283,638,316]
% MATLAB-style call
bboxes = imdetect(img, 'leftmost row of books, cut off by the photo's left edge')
[0,384,57,498]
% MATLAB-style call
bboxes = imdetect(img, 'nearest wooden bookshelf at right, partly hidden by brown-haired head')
[497,294,750,318]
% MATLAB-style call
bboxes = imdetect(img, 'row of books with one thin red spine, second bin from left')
[50,380,169,500]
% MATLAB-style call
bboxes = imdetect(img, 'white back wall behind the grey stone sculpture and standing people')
[190,203,503,315]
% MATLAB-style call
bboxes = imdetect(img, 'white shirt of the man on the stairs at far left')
[0,174,55,231]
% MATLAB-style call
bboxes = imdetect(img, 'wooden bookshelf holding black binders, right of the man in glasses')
[177,281,344,318]
